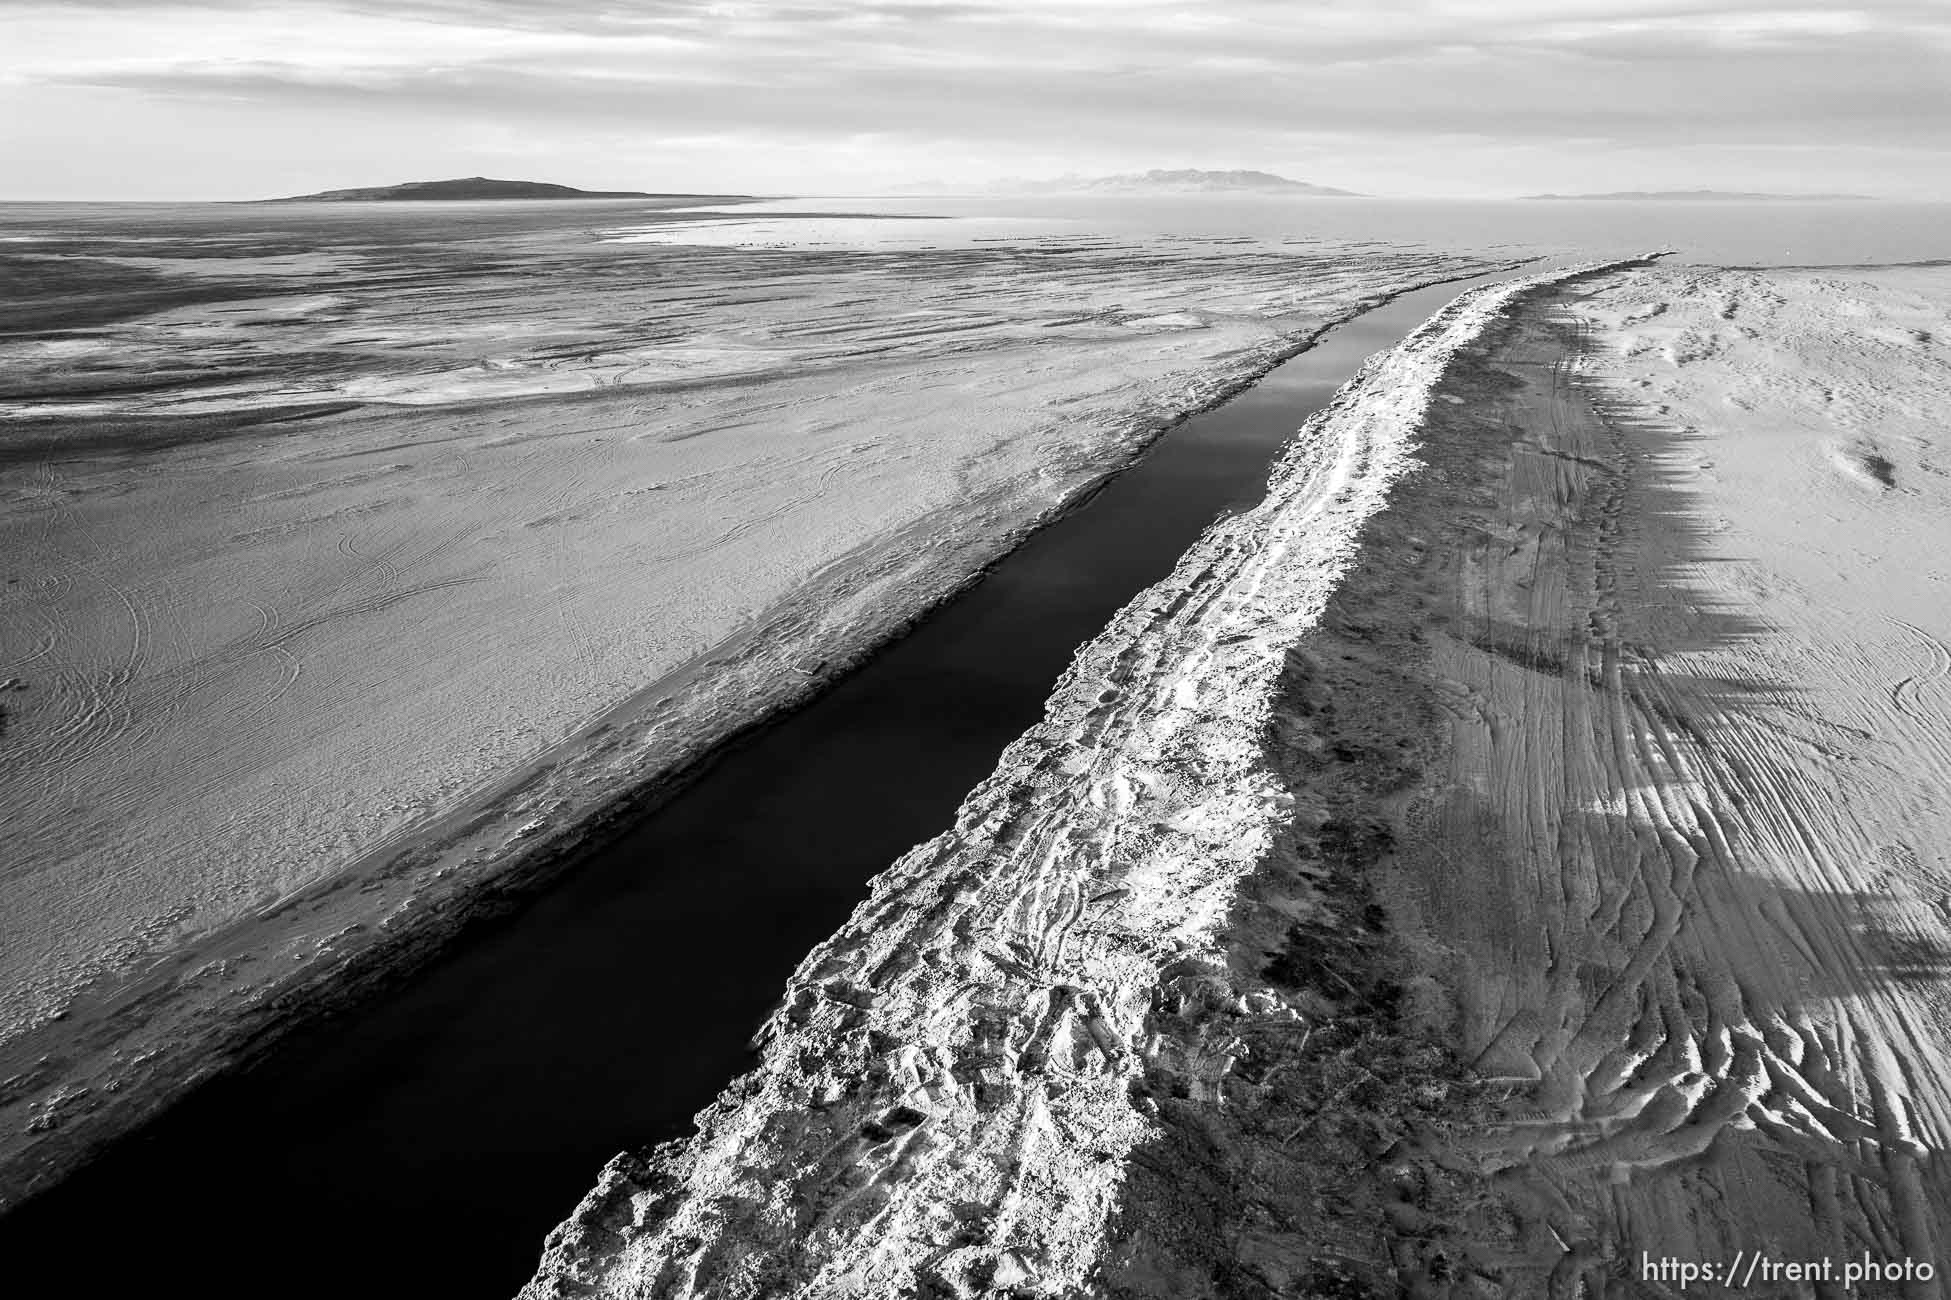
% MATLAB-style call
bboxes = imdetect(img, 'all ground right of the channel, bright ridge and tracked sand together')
[525,257,1951,1300]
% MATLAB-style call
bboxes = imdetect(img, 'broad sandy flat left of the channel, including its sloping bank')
[0,209,1485,1195]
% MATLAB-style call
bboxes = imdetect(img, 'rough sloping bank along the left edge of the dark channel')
[0,264,1518,1204]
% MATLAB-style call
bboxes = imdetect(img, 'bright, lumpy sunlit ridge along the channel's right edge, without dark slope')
[523,257,1646,1296]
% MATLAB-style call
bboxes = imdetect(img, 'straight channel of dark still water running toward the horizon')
[0,267,1498,1300]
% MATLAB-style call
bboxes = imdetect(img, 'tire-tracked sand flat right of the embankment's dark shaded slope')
[1397,267,1951,1296]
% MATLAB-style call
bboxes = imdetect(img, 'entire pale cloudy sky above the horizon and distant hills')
[0,0,1951,199]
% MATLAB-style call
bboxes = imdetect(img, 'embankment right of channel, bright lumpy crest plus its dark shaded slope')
[525,269,1646,1300]
